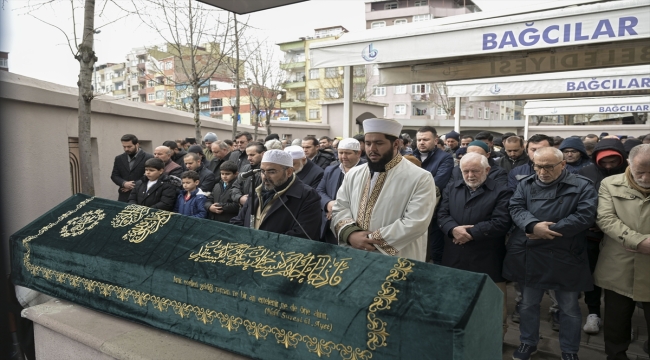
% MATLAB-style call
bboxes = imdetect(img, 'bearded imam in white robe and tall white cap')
[330,119,436,261]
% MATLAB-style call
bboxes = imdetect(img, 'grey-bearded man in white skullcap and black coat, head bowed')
[230,149,321,241]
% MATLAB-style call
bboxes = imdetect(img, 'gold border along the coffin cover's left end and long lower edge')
[23,197,370,360]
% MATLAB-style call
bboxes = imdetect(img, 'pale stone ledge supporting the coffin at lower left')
[22,299,248,360]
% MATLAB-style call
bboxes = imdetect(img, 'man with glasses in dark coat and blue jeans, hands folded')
[503,147,598,360]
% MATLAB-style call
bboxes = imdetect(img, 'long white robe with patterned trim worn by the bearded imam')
[331,155,436,261]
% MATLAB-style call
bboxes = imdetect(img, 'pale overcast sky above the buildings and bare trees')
[0,0,548,86]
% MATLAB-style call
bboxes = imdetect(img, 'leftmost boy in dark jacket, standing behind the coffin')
[129,158,176,211]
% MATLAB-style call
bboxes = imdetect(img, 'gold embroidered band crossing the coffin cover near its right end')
[366,258,415,351]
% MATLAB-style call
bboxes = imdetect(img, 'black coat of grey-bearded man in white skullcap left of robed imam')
[230,178,321,241]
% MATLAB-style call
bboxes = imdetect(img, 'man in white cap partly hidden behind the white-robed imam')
[316,138,366,244]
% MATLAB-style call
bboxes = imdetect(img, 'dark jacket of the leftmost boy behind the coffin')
[129,174,178,211]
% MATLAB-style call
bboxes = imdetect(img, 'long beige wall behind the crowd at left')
[0,72,326,267]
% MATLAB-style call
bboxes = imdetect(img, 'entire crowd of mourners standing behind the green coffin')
[111,124,650,360]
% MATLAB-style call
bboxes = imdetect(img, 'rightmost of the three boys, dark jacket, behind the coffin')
[204,160,239,223]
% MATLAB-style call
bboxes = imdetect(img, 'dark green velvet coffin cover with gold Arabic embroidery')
[11,195,503,360]
